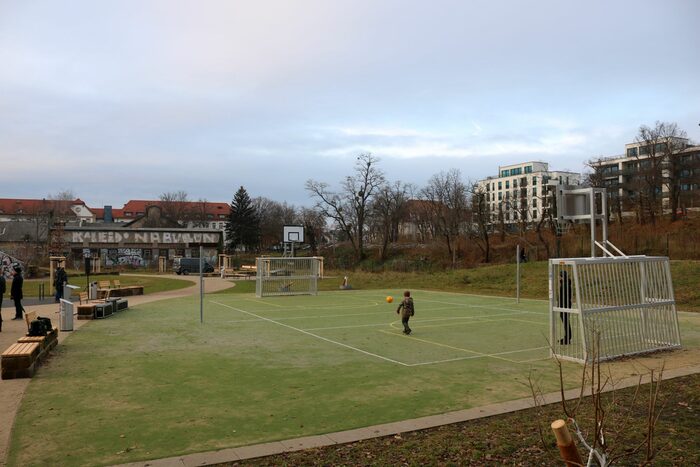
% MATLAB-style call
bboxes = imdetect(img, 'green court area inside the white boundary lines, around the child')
[210,290,549,367]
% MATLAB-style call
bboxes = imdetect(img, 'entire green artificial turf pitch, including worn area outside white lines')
[9,290,700,466]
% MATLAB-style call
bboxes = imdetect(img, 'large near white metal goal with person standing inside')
[549,256,681,363]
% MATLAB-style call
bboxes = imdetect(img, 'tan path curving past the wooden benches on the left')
[0,274,235,466]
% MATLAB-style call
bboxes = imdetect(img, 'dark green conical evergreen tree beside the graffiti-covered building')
[226,187,260,254]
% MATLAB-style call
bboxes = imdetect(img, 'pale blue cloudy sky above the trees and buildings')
[0,0,700,207]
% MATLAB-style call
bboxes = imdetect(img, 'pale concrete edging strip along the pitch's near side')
[114,365,700,467]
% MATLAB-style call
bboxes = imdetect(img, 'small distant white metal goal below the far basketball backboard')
[255,258,321,297]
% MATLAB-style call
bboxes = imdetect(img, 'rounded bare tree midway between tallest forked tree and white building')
[422,169,468,267]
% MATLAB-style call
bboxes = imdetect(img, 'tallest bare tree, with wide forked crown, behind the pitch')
[306,153,385,261]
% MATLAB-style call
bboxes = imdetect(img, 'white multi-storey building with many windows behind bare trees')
[477,161,581,224]
